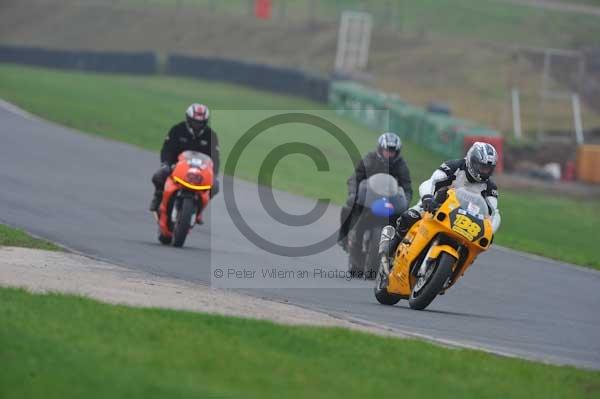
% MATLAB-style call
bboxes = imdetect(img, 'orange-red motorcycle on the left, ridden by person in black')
[155,151,214,247]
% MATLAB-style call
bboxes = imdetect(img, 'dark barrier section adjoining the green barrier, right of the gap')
[166,54,329,103]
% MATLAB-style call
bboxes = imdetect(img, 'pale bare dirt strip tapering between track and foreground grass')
[0,247,401,336]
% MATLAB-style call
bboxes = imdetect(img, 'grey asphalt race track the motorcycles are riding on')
[0,108,600,369]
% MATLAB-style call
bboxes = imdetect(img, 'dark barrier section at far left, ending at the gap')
[0,46,158,74]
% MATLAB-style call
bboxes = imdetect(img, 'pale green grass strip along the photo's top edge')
[127,0,600,47]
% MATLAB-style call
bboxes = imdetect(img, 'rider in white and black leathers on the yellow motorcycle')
[383,142,501,256]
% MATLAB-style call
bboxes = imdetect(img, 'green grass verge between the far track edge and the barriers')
[0,65,600,269]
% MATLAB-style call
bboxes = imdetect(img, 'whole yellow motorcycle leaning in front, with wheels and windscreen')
[374,187,493,310]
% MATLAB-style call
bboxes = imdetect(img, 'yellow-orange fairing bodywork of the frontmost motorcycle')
[387,189,492,298]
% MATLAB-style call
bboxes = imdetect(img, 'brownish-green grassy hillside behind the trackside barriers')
[0,0,600,137]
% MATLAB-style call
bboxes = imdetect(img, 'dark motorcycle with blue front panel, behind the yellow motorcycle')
[348,173,408,280]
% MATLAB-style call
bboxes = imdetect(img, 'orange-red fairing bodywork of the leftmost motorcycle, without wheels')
[158,151,213,237]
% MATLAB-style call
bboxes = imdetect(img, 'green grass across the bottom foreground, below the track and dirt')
[0,288,600,399]
